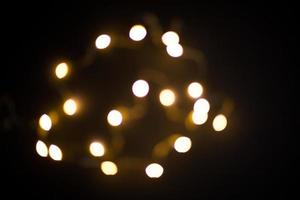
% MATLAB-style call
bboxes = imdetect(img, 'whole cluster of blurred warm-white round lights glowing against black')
[36,25,227,178]
